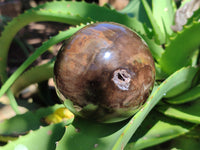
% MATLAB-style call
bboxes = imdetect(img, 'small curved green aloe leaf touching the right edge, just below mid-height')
[165,85,200,104]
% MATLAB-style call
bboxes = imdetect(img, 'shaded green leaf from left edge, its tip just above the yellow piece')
[0,104,63,136]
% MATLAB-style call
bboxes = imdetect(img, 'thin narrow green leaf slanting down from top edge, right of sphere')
[142,0,165,44]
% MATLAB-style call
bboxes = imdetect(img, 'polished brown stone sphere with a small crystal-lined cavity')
[54,22,155,122]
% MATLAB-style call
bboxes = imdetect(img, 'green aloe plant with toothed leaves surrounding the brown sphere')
[0,0,200,150]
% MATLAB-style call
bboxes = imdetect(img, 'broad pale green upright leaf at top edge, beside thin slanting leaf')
[152,0,175,35]
